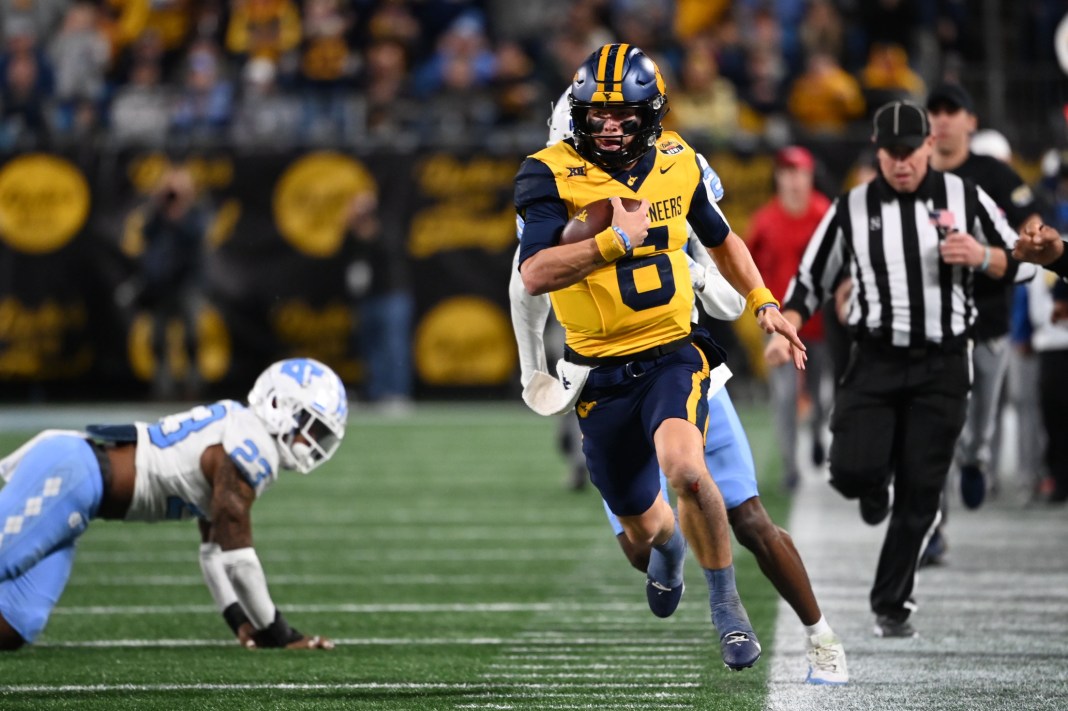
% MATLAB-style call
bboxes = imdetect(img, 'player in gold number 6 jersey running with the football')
[515,44,804,670]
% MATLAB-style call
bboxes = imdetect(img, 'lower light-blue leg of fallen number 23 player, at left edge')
[0,542,75,651]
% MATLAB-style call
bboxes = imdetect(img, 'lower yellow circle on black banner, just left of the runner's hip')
[415,297,516,385]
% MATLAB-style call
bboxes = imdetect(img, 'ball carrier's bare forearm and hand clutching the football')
[519,198,649,296]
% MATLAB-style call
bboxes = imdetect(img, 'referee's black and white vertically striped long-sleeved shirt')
[784,170,1017,348]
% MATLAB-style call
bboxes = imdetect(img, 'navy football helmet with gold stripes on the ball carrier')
[570,44,668,171]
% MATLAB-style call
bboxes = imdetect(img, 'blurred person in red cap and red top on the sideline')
[745,145,831,490]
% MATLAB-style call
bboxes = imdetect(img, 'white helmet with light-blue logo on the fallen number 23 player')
[249,358,348,474]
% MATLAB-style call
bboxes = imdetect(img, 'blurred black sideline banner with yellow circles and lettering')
[0,143,803,401]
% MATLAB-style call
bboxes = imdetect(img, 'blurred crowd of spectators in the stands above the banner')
[0,0,1066,151]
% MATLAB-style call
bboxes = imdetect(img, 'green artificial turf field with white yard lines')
[0,405,788,711]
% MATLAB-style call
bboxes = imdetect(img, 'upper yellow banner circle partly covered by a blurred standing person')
[273,151,377,257]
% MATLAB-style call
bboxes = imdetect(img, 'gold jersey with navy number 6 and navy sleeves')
[516,131,731,357]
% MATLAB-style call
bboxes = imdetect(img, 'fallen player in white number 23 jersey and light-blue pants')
[0,359,348,650]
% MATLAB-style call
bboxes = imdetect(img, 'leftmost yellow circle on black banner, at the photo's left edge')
[0,153,90,254]
